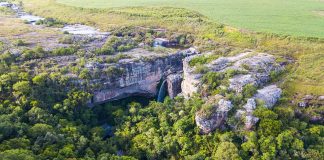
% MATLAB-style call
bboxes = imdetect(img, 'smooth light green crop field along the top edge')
[57,0,324,37]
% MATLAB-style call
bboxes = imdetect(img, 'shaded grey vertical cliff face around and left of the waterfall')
[87,49,195,104]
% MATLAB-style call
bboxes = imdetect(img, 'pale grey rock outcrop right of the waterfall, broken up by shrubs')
[189,52,284,134]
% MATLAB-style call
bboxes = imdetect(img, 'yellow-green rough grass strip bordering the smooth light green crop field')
[16,0,324,95]
